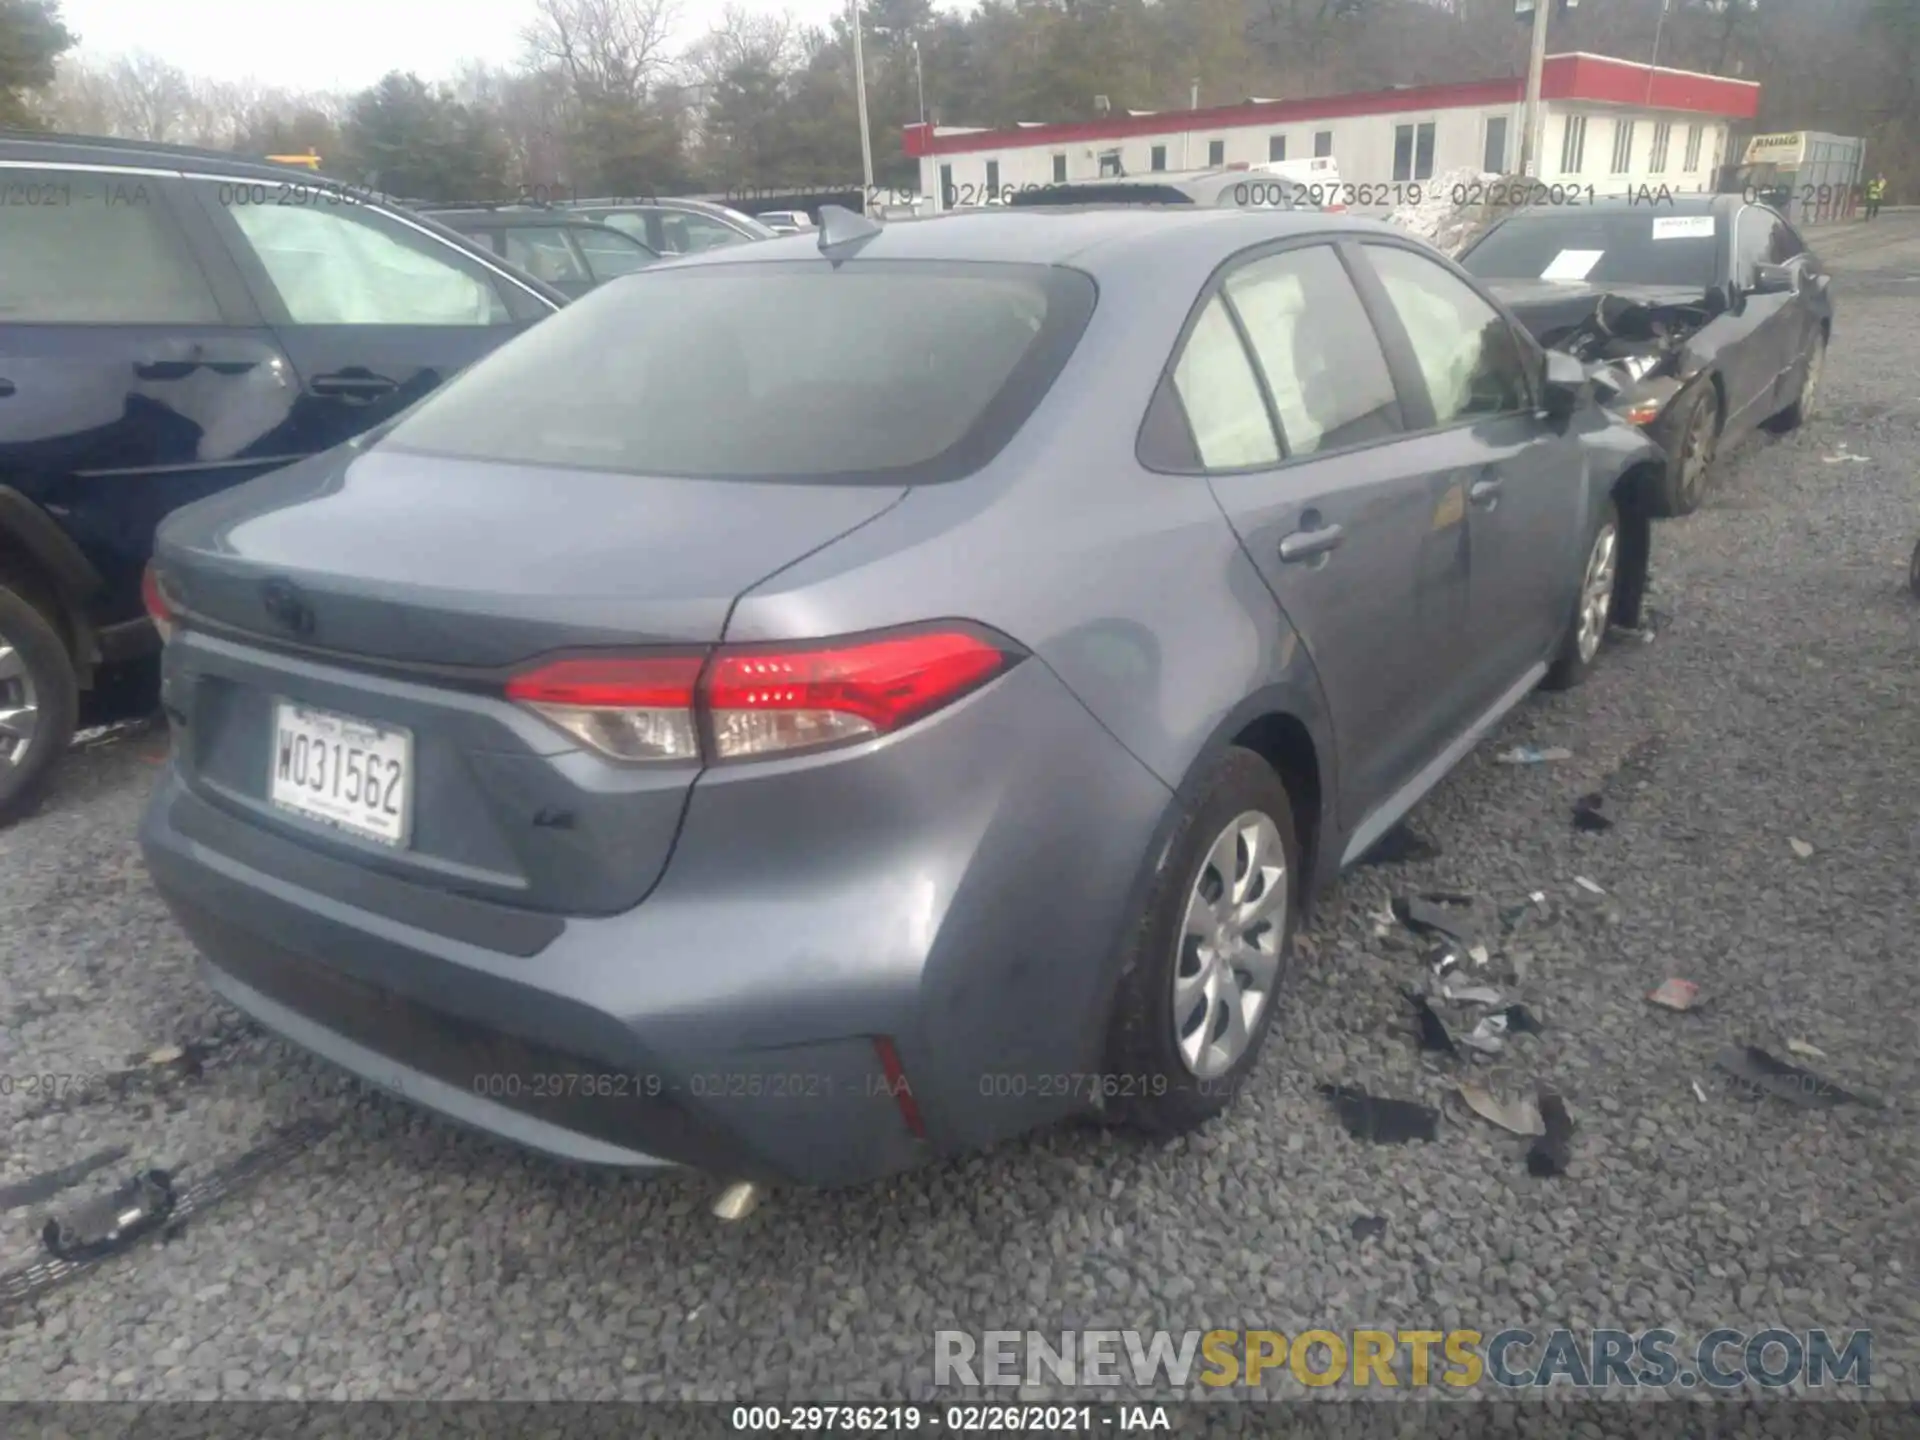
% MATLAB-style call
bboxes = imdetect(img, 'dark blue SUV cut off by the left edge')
[0,131,566,824]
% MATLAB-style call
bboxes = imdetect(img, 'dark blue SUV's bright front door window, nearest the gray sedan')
[198,180,513,326]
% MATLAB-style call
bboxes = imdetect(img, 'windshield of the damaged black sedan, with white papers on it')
[1459,205,1720,290]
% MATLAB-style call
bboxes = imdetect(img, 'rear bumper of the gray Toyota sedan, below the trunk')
[142,660,1169,1187]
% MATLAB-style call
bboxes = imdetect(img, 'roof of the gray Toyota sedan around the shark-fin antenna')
[668,205,1409,276]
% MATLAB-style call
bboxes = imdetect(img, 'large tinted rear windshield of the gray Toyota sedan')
[380,259,1094,484]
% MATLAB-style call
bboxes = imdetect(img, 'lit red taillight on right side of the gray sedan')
[507,630,1014,760]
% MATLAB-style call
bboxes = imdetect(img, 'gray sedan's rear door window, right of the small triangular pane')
[1225,246,1400,455]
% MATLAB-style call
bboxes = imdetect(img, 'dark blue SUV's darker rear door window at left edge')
[0,169,221,324]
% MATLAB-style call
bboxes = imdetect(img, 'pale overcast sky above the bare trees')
[60,0,879,90]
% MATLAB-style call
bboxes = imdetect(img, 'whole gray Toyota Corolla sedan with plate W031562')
[142,207,1661,1185]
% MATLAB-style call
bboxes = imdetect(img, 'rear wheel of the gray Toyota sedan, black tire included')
[1100,749,1306,1137]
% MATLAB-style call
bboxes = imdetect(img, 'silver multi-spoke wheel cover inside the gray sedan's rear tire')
[1173,810,1288,1079]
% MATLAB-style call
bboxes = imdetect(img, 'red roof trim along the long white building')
[900,54,1761,157]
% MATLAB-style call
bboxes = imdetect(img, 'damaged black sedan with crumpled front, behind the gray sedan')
[1459,194,1834,515]
